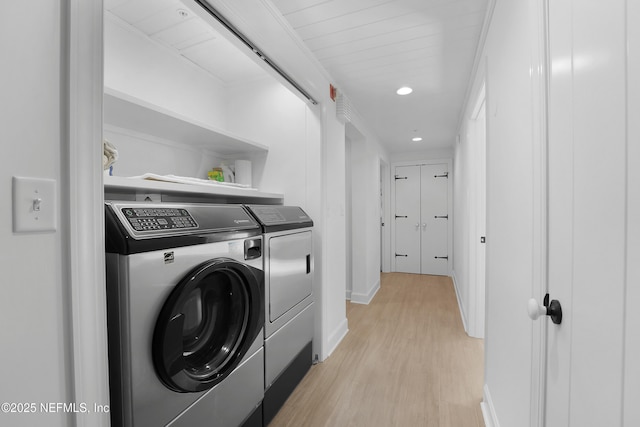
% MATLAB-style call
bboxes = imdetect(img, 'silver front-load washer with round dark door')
[105,202,264,427]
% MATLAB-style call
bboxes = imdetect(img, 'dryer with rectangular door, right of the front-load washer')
[247,205,314,425]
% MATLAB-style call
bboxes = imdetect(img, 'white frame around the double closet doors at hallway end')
[389,158,454,276]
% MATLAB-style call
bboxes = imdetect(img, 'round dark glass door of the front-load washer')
[152,258,264,393]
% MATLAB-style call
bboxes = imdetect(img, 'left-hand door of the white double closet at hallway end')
[394,166,420,274]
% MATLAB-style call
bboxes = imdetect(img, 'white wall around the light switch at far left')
[0,0,72,426]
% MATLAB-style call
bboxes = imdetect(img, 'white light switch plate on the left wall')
[13,176,58,233]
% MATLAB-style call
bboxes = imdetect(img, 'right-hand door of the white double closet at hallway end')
[420,164,449,276]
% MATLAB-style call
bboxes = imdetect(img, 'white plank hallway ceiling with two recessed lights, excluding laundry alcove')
[271,0,487,153]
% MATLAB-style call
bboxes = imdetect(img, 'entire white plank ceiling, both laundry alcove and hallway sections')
[104,0,487,154]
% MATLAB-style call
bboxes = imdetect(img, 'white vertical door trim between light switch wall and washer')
[67,0,110,427]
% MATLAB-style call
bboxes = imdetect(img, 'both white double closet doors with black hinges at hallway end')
[394,163,449,275]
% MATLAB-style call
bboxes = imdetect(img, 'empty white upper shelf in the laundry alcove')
[104,87,269,156]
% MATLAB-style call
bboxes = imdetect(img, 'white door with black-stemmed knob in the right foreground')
[545,0,640,427]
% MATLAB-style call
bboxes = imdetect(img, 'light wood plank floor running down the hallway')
[269,273,484,427]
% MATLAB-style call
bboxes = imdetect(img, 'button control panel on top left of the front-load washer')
[121,207,198,232]
